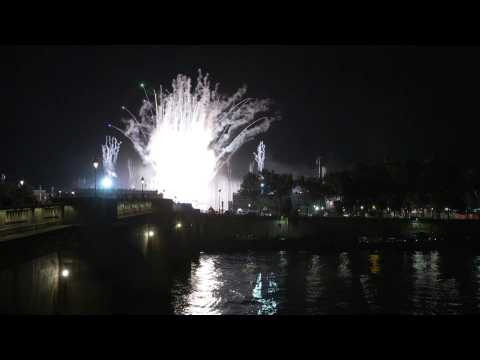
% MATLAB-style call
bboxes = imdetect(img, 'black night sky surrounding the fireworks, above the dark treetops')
[0,45,480,186]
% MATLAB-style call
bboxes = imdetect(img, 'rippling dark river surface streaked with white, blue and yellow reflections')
[174,251,480,315]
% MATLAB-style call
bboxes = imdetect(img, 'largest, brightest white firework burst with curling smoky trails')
[112,71,275,208]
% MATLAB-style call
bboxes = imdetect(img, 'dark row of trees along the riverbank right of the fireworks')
[239,160,480,217]
